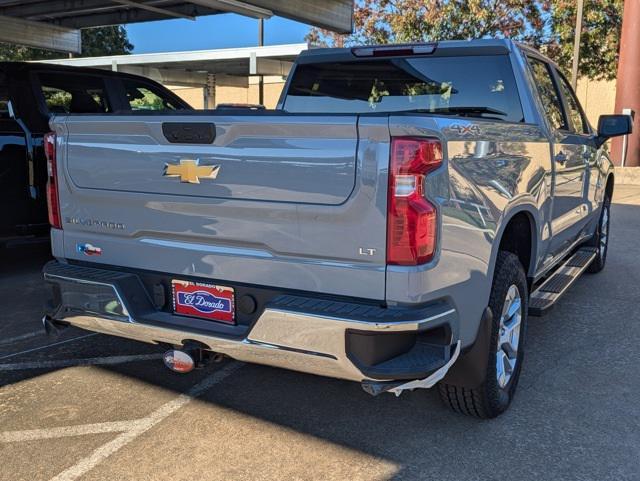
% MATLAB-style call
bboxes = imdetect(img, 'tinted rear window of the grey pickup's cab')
[284,55,524,122]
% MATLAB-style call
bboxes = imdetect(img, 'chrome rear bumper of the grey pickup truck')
[44,261,459,381]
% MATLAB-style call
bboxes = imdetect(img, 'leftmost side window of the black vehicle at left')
[38,73,111,114]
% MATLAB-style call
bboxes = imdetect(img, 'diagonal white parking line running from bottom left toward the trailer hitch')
[50,362,242,481]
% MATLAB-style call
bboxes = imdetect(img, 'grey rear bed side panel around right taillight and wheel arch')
[387,115,552,346]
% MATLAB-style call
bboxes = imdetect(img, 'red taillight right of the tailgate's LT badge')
[387,137,442,266]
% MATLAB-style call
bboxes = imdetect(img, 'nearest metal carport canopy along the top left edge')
[0,0,353,52]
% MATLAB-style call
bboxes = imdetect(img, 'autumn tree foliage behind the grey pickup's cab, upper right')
[307,0,624,79]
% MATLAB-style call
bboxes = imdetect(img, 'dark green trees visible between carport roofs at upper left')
[0,25,133,61]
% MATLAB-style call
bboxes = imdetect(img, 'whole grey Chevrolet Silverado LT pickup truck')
[44,40,631,417]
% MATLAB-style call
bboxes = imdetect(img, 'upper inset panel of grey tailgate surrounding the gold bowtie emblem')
[67,116,358,205]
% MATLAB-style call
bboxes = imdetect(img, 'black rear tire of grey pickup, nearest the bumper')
[438,251,529,419]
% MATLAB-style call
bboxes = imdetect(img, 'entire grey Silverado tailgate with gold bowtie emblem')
[53,114,389,299]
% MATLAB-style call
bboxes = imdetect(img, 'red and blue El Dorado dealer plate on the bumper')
[171,280,235,324]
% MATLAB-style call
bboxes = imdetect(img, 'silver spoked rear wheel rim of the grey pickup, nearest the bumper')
[496,284,522,388]
